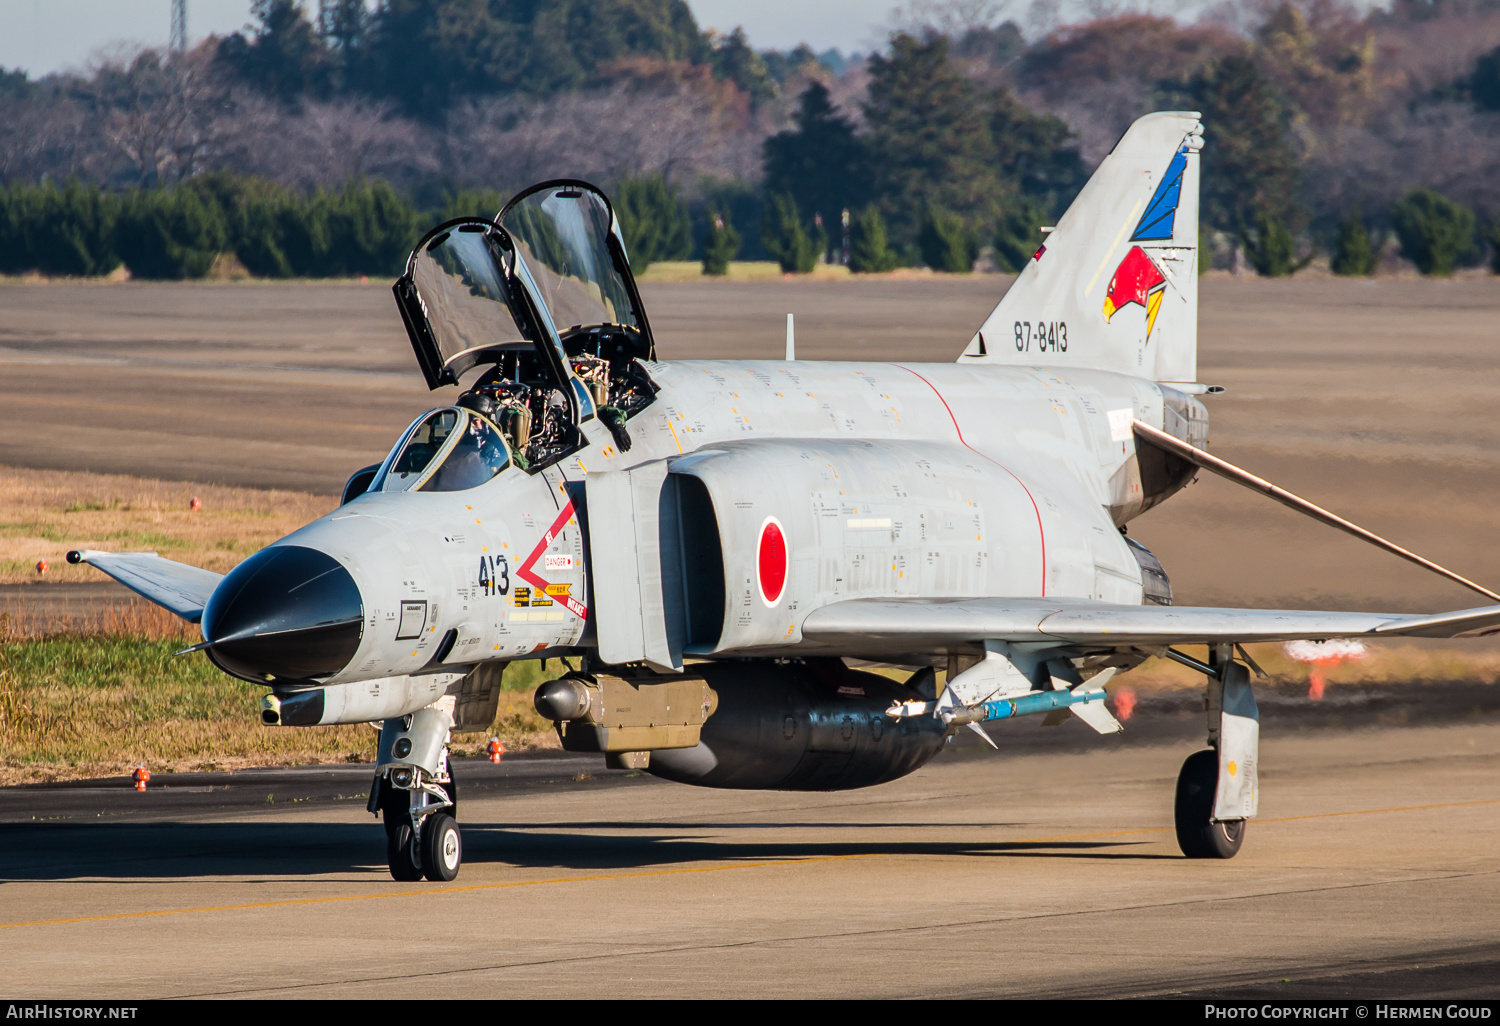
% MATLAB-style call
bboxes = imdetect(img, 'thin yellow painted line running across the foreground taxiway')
[0,798,1500,930]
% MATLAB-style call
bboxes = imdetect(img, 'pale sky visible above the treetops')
[0,0,896,78]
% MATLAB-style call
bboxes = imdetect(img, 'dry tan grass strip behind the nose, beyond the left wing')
[0,467,335,584]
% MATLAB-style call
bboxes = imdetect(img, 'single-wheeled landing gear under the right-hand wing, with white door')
[1173,645,1260,858]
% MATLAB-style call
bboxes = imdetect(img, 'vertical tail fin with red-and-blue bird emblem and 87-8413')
[959,111,1203,383]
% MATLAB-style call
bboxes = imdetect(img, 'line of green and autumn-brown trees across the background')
[0,0,1500,276]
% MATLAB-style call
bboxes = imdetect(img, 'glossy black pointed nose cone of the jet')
[203,545,365,680]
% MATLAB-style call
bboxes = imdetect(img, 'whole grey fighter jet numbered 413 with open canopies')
[69,113,1500,881]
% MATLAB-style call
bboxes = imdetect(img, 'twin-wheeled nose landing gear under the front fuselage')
[369,708,464,882]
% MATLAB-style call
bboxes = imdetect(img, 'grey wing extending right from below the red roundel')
[803,599,1500,654]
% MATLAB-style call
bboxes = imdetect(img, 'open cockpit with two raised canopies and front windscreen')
[387,180,657,474]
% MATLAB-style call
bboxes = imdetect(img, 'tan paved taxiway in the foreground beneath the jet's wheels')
[0,704,1500,998]
